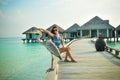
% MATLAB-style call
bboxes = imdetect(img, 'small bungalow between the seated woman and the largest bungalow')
[64,23,80,39]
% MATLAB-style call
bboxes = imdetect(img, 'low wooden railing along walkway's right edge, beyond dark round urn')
[105,46,120,58]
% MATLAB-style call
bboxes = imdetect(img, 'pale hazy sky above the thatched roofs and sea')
[0,0,120,38]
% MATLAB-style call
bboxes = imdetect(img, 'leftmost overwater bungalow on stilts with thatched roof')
[22,27,39,43]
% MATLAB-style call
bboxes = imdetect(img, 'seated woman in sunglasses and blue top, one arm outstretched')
[38,27,76,62]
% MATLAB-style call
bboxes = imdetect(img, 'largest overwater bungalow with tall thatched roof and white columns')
[78,16,114,38]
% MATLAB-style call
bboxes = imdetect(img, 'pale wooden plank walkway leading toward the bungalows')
[57,39,120,80]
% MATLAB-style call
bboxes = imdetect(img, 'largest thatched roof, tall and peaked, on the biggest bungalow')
[80,16,113,30]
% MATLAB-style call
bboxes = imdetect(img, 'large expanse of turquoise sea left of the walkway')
[0,38,51,80]
